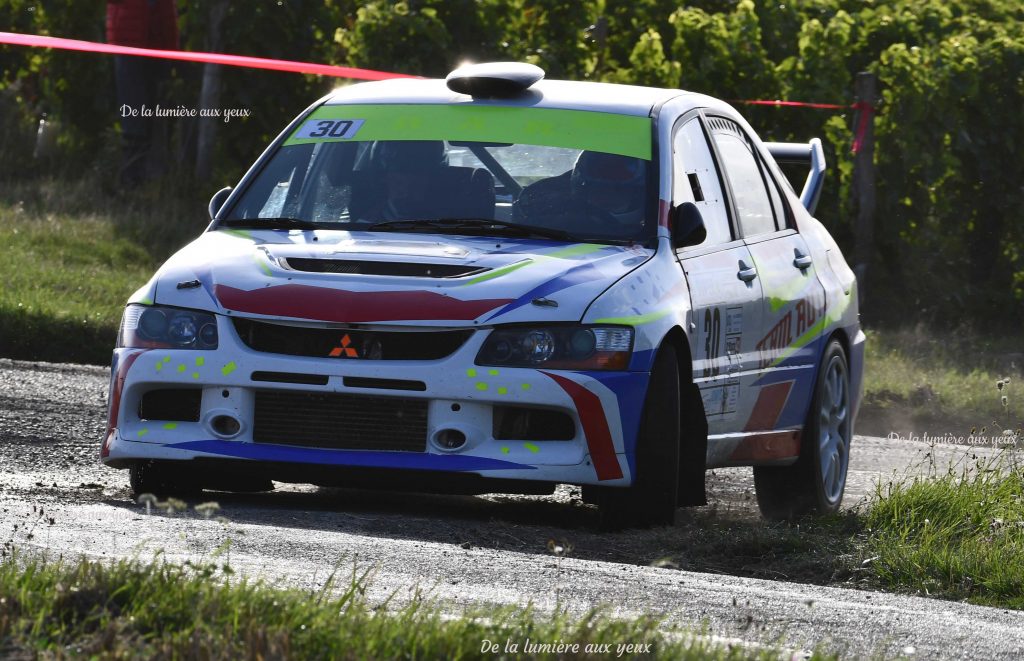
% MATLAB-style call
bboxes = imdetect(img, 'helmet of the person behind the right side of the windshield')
[570,151,646,225]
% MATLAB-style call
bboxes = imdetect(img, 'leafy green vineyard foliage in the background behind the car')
[0,0,1024,323]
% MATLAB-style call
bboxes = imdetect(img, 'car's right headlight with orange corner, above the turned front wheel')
[476,325,633,369]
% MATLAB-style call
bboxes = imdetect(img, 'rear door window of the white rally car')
[709,118,777,236]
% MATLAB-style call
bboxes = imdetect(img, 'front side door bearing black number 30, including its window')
[672,113,762,439]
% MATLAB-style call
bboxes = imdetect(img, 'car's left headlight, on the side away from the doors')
[118,305,217,349]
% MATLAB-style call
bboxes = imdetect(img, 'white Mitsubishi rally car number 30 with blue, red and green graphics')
[101,63,864,526]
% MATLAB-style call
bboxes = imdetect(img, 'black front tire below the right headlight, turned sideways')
[598,344,680,530]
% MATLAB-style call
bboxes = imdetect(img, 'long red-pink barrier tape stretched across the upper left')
[0,32,418,80]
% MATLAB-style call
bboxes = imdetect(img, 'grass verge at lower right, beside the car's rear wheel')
[630,450,1024,610]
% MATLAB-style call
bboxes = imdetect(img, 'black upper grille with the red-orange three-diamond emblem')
[232,318,473,360]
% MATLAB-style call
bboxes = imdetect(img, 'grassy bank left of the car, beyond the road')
[0,176,205,364]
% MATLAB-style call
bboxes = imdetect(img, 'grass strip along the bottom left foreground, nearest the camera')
[0,559,811,659]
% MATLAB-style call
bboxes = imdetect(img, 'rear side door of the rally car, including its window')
[708,117,825,448]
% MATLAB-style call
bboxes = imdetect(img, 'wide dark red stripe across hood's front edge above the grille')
[214,284,512,322]
